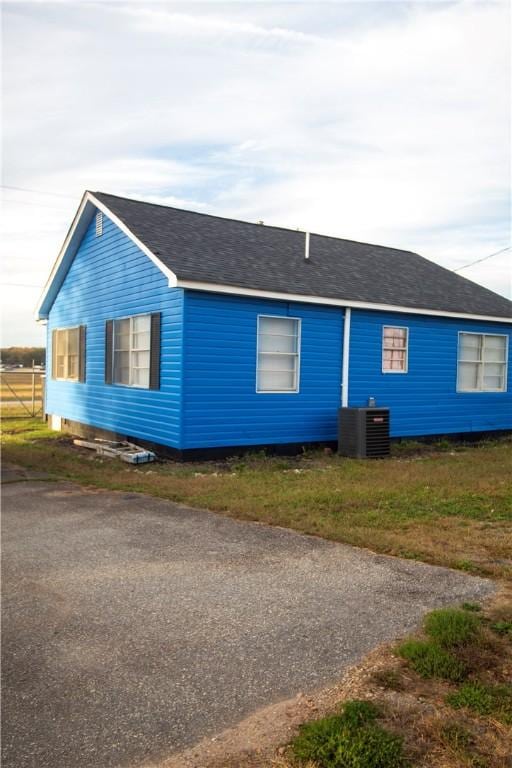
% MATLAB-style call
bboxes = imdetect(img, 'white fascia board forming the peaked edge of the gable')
[36,192,177,320]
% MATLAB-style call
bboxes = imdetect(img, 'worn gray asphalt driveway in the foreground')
[2,481,493,768]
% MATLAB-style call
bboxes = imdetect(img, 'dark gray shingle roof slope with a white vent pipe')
[93,192,512,318]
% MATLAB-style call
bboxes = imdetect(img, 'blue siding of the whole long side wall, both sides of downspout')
[182,291,512,448]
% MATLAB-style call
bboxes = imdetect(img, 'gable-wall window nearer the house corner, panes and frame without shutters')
[113,315,151,389]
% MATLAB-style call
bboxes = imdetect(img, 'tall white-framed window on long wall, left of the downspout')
[256,315,300,392]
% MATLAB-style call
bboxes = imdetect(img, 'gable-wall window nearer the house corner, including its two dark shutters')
[105,312,160,389]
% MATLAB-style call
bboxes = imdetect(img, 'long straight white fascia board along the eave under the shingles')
[176,279,512,323]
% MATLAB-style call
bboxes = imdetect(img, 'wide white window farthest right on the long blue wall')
[457,333,508,392]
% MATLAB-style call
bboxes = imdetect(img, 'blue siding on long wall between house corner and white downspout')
[183,291,343,448]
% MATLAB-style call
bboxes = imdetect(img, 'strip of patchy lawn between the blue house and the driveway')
[3,420,512,579]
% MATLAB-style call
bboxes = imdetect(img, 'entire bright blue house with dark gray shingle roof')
[37,192,512,457]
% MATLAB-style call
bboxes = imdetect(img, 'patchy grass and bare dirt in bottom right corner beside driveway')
[276,588,512,768]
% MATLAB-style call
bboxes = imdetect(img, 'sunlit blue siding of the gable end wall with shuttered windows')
[46,216,183,447]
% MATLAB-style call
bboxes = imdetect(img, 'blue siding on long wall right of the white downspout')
[349,310,512,436]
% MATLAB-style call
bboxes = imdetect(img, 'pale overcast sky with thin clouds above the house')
[2,0,511,345]
